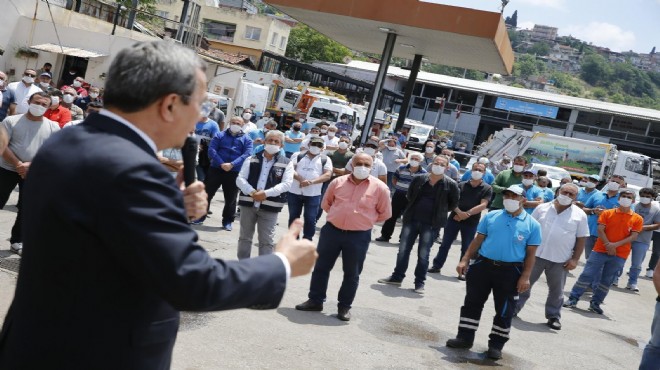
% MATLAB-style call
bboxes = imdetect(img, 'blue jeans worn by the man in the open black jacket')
[392,221,438,286]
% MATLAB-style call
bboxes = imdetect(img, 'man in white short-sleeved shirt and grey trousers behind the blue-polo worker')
[515,183,589,330]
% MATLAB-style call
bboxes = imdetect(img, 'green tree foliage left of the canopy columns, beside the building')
[286,23,352,63]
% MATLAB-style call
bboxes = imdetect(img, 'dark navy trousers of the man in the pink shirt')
[308,222,371,308]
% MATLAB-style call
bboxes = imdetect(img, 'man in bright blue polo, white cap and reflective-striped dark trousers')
[447,185,541,359]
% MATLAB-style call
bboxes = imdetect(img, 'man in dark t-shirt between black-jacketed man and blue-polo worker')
[428,162,493,280]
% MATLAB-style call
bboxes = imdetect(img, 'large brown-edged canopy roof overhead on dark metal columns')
[266,0,513,74]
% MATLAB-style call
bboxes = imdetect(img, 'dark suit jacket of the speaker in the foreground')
[0,114,286,370]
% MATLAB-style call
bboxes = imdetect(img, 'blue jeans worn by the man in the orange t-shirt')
[570,252,626,304]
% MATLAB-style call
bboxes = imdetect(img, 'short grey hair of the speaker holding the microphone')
[103,41,206,113]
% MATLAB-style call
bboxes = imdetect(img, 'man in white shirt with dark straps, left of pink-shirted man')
[287,137,332,240]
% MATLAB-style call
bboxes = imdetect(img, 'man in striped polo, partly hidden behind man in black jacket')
[376,153,427,242]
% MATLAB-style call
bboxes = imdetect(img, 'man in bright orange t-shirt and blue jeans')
[564,188,644,315]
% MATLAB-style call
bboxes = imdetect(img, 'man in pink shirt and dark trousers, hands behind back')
[296,153,392,321]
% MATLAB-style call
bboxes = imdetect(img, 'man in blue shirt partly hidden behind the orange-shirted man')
[582,175,625,259]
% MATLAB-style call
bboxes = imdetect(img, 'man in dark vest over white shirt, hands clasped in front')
[236,130,293,259]
